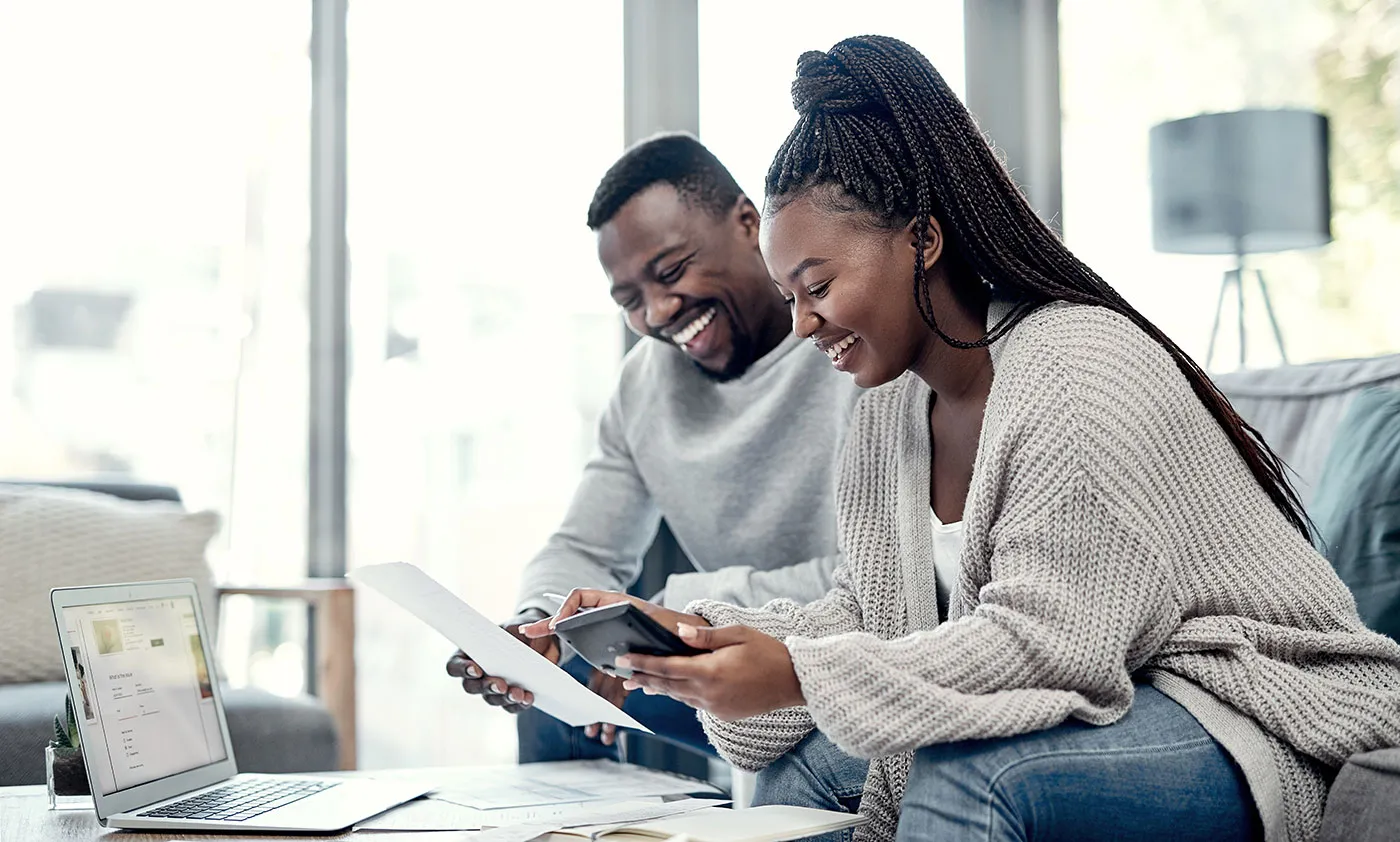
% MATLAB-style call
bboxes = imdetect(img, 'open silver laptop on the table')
[50,579,431,832]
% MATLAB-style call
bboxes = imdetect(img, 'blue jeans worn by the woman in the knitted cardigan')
[759,685,1263,842]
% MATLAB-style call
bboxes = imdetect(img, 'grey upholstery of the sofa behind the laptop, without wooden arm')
[0,483,341,786]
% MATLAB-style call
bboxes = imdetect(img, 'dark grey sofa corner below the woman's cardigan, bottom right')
[1317,748,1400,842]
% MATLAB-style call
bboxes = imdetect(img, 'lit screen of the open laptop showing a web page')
[63,597,228,794]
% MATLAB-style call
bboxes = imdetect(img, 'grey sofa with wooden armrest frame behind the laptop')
[0,482,356,786]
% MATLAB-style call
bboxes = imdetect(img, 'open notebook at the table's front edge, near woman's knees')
[546,804,865,842]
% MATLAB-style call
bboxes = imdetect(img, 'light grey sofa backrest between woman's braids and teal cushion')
[1212,354,1400,511]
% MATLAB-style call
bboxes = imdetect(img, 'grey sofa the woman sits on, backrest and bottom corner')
[1215,354,1400,842]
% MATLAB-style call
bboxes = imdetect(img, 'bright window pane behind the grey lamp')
[1060,0,1400,368]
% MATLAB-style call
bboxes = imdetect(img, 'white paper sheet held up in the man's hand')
[349,562,651,734]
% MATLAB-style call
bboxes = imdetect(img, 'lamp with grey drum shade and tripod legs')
[1149,109,1331,368]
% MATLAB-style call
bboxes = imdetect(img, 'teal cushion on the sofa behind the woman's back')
[1312,389,1400,640]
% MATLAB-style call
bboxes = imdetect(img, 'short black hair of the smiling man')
[588,132,743,231]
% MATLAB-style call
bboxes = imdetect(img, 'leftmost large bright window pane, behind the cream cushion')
[0,0,311,692]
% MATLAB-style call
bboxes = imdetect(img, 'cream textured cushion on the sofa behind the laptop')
[0,485,220,684]
